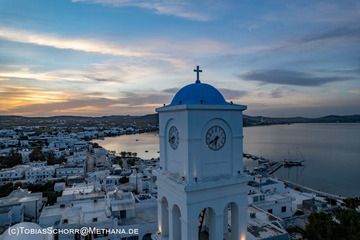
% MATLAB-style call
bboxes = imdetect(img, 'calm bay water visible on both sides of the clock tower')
[96,123,360,196]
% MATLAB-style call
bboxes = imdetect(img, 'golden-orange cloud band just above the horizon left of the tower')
[0,92,168,116]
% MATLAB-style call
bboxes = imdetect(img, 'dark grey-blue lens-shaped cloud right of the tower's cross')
[238,69,351,86]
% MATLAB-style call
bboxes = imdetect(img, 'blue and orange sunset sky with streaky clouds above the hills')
[0,0,360,117]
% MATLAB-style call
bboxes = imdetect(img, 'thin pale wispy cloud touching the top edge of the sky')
[73,0,210,21]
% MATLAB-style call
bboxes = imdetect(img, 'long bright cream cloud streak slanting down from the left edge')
[0,27,149,57]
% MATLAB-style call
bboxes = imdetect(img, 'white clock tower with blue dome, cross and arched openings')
[156,67,248,240]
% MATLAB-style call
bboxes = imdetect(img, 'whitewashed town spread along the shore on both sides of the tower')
[0,116,359,240]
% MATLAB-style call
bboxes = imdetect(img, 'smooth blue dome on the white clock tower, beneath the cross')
[170,81,228,106]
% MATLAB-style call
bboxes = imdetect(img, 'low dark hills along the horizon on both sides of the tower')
[0,114,360,128]
